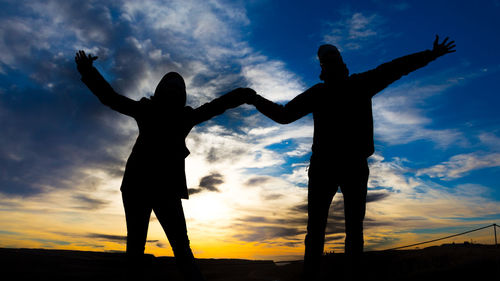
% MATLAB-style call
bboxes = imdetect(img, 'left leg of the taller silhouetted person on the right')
[302,161,337,280]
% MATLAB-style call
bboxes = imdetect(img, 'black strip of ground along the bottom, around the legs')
[0,244,500,281]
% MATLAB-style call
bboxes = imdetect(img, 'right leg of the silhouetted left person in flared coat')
[153,199,205,281]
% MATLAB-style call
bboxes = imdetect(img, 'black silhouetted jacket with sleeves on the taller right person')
[254,50,436,161]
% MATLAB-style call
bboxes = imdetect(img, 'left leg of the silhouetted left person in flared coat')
[122,192,152,280]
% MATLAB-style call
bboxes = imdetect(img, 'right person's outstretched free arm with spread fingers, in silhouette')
[352,35,456,96]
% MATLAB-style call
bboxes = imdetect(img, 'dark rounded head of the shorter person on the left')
[151,72,186,107]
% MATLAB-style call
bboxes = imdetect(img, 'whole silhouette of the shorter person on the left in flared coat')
[75,51,255,280]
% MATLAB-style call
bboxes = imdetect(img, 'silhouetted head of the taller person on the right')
[318,44,349,82]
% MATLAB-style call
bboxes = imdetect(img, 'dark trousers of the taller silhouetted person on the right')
[304,156,369,280]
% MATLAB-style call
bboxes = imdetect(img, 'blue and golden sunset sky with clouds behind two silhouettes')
[0,0,500,260]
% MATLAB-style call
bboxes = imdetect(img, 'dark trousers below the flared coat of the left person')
[122,191,205,280]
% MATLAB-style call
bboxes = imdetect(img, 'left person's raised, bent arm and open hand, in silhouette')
[75,51,137,116]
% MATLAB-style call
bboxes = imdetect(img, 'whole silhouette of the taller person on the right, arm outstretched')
[249,35,455,280]
